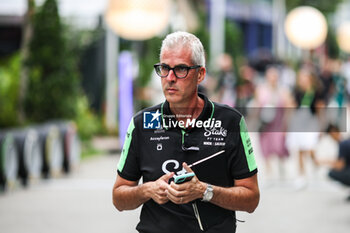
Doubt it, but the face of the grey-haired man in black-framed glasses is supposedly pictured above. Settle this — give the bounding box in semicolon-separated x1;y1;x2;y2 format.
160;47;205;105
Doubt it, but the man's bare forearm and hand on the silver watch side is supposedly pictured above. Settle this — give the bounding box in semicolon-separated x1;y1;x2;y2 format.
167;164;260;213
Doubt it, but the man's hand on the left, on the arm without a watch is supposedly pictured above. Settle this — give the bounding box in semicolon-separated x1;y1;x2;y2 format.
148;172;174;205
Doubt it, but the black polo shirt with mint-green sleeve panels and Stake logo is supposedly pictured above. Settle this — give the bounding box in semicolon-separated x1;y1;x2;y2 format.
118;94;257;233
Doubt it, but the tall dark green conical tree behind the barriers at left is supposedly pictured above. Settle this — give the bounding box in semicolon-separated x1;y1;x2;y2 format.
26;0;79;122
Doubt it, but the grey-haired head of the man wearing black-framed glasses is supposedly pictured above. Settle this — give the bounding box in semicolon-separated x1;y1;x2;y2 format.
156;32;206;106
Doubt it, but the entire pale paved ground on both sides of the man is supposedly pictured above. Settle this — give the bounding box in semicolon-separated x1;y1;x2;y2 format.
0;147;350;233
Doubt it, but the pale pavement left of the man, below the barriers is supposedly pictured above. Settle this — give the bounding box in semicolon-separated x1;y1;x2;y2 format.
0;155;138;233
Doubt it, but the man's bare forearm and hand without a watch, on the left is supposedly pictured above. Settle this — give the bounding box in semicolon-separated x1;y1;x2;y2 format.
113;173;174;211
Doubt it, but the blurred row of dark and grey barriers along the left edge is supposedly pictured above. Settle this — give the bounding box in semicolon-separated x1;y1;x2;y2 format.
0;121;81;190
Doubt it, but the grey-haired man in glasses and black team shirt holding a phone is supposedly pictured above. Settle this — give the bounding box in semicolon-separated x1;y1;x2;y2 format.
113;32;259;233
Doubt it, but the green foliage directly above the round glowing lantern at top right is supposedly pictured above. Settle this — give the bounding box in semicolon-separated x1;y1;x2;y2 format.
286;0;343;14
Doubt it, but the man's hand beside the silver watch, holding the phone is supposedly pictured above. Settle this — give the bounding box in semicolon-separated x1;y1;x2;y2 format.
166;163;206;204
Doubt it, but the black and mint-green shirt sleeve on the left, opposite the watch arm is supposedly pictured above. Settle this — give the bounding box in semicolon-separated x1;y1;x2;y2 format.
118;118;141;181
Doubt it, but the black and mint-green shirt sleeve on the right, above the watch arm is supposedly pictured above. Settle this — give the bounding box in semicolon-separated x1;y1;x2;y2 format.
230;117;257;179
